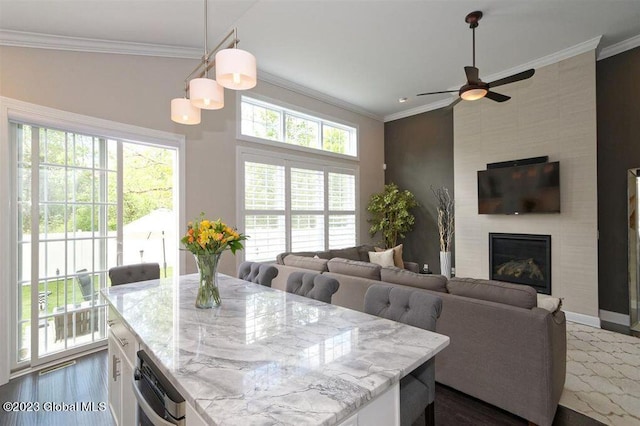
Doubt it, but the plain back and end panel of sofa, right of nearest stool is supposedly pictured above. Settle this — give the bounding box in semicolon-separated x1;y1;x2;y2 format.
436;293;566;426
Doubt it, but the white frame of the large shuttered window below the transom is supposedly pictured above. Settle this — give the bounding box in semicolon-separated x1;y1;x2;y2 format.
236;146;360;261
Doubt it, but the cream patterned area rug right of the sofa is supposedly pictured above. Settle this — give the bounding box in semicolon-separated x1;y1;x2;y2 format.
560;321;640;426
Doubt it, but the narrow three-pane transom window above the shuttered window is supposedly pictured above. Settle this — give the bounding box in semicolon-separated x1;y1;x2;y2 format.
239;96;358;157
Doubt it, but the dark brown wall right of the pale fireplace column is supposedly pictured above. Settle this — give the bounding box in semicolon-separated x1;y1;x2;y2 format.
596;48;640;314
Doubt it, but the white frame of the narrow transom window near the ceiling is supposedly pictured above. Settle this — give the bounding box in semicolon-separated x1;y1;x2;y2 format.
236;92;360;161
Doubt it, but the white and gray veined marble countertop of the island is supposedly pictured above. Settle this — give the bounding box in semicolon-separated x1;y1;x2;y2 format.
104;274;449;425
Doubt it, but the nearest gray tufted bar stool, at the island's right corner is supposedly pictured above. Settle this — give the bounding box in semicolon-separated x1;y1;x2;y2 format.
364;284;442;426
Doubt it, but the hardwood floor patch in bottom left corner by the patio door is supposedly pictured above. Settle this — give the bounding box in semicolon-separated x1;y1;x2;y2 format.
0;349;115;426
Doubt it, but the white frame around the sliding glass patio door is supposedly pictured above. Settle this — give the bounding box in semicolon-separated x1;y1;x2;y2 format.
0;96;186;385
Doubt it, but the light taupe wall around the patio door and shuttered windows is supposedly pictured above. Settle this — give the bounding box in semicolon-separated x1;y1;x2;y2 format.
0;47;384;273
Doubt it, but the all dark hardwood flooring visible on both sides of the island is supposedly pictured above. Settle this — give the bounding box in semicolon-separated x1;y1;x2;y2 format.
0;350;602;426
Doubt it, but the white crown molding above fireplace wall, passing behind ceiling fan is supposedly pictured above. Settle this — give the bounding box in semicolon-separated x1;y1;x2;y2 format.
384;35;604;122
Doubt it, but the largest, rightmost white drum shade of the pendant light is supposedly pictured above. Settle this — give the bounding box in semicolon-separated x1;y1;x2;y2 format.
216;48;258;90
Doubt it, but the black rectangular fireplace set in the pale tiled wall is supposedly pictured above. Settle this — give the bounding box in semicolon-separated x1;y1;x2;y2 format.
489;232;551;294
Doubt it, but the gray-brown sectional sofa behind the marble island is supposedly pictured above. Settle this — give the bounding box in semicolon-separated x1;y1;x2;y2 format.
272;253;566;425
